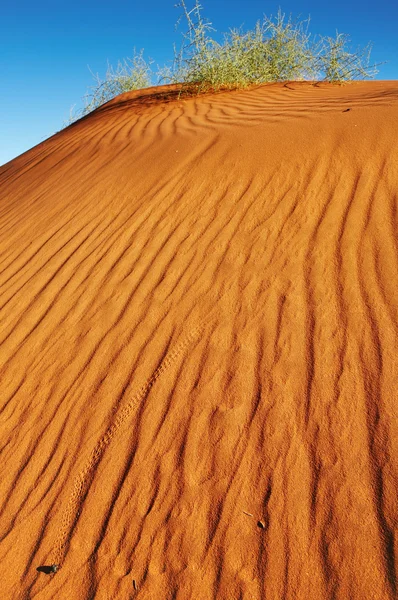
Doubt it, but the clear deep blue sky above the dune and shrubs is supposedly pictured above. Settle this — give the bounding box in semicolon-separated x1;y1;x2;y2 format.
0;0;398;165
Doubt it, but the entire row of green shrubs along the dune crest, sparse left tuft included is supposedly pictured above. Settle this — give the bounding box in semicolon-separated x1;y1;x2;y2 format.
69;0;378;123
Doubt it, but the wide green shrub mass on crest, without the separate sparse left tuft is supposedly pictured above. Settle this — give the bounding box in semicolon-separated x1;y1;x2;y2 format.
164;0;377;92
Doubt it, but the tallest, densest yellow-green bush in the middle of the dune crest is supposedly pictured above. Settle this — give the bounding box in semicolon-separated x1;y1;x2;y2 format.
164;0;312;92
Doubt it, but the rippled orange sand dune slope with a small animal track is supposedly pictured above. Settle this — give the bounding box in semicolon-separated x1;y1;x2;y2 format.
0;82;398;600
